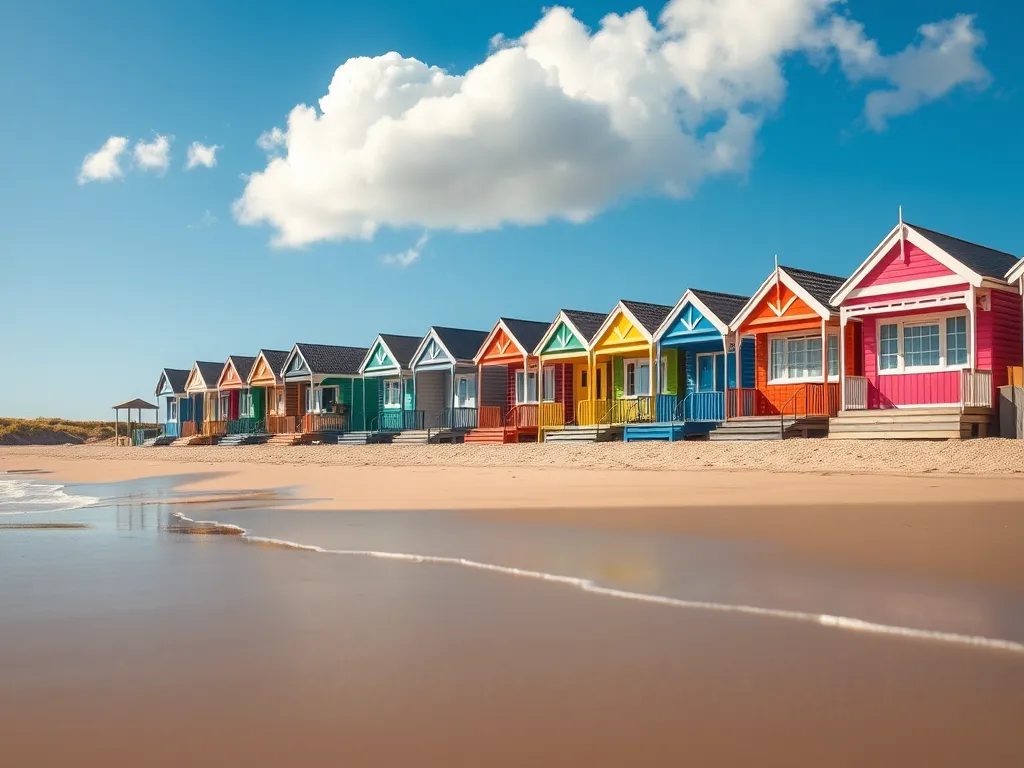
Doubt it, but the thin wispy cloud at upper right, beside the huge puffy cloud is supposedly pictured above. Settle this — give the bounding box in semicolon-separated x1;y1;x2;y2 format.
833;14;991;130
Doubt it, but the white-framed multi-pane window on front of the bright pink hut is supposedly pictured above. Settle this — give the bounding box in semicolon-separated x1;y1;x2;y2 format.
878;314;970;374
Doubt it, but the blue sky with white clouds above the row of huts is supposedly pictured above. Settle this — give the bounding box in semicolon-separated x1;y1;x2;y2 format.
0;0;1024;419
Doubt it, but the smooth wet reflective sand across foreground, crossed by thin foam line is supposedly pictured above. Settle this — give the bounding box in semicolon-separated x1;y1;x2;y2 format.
0;477;1024;766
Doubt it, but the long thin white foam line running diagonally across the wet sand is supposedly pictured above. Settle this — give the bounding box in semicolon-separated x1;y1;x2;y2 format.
172;512;1024;654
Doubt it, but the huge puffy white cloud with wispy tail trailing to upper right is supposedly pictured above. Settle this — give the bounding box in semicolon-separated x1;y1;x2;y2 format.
234;0;983;247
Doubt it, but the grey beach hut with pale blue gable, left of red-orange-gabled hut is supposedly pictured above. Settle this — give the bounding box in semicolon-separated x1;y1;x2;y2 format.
401;326;487;442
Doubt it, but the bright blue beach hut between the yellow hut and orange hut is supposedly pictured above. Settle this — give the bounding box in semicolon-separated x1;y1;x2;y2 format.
623;289;754;441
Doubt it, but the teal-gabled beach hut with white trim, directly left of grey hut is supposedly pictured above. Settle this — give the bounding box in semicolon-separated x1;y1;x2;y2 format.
359;334;426;441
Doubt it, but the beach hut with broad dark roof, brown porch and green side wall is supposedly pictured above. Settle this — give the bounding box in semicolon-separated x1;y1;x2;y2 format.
271;343;377;444
